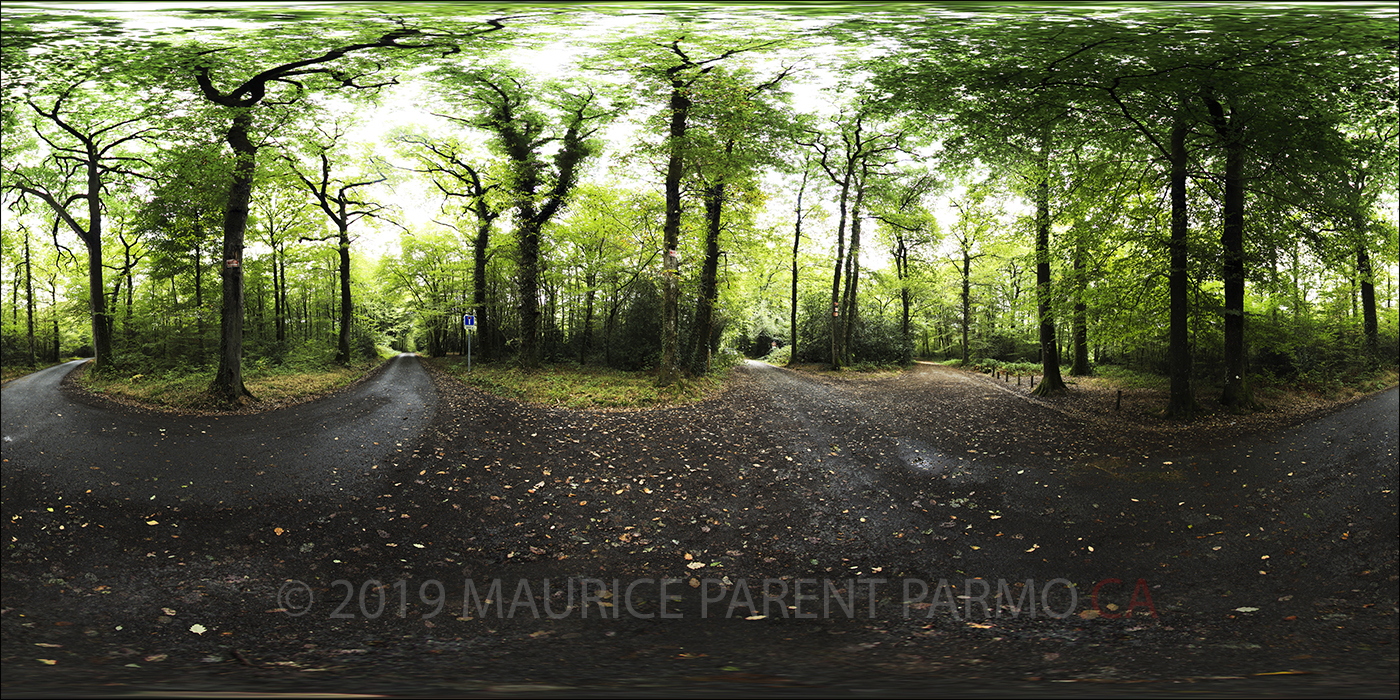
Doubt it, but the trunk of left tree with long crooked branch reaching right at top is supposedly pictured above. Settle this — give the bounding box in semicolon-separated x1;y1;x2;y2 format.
209;111;258;405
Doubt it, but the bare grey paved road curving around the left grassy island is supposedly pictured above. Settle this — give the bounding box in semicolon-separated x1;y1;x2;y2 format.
0;354;437;505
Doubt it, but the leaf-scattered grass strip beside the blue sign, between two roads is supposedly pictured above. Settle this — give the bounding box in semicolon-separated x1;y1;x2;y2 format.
428;357;724;410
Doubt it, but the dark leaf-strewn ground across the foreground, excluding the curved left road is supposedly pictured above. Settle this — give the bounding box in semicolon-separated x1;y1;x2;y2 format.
0;363;1400;697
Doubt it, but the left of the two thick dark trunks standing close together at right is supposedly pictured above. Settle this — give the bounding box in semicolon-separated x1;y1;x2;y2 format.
1166;106;1197;419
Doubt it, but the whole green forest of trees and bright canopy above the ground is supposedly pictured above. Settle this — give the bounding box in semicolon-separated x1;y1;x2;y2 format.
0;3;1400;416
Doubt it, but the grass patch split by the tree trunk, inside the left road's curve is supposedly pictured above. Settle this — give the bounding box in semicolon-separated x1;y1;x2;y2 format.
77;360;382;412
